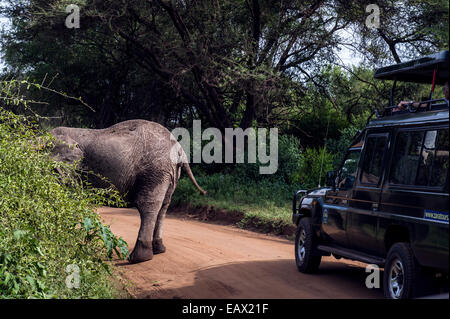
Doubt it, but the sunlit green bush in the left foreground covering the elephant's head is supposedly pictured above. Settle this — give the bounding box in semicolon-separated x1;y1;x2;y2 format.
0;106;128;298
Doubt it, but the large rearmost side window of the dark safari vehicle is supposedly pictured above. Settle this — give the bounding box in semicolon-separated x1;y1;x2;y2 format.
390;129;449;187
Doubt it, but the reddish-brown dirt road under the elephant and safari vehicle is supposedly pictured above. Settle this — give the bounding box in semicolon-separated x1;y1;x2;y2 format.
99;208;383;299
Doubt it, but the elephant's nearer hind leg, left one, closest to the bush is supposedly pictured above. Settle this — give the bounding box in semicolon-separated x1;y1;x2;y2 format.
129;185;167;263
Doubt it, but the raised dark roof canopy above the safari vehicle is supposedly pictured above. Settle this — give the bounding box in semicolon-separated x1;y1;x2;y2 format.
374;50;449;85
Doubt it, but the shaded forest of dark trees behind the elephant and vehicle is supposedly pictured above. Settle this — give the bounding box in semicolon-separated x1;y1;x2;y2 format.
1;0;448;187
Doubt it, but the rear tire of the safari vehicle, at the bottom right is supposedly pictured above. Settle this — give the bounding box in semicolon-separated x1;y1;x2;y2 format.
383;243;420;299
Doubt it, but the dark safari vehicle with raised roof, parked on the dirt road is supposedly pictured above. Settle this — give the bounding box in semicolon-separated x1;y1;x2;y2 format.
293;51;449;299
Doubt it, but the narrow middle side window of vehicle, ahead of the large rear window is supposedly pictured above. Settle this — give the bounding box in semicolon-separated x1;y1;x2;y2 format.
361;135;387;185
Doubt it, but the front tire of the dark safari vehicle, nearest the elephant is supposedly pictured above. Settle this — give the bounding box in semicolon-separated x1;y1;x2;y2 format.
295;217;322;273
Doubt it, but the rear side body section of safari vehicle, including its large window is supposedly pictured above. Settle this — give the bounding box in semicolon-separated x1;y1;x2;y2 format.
378;123;449;268
